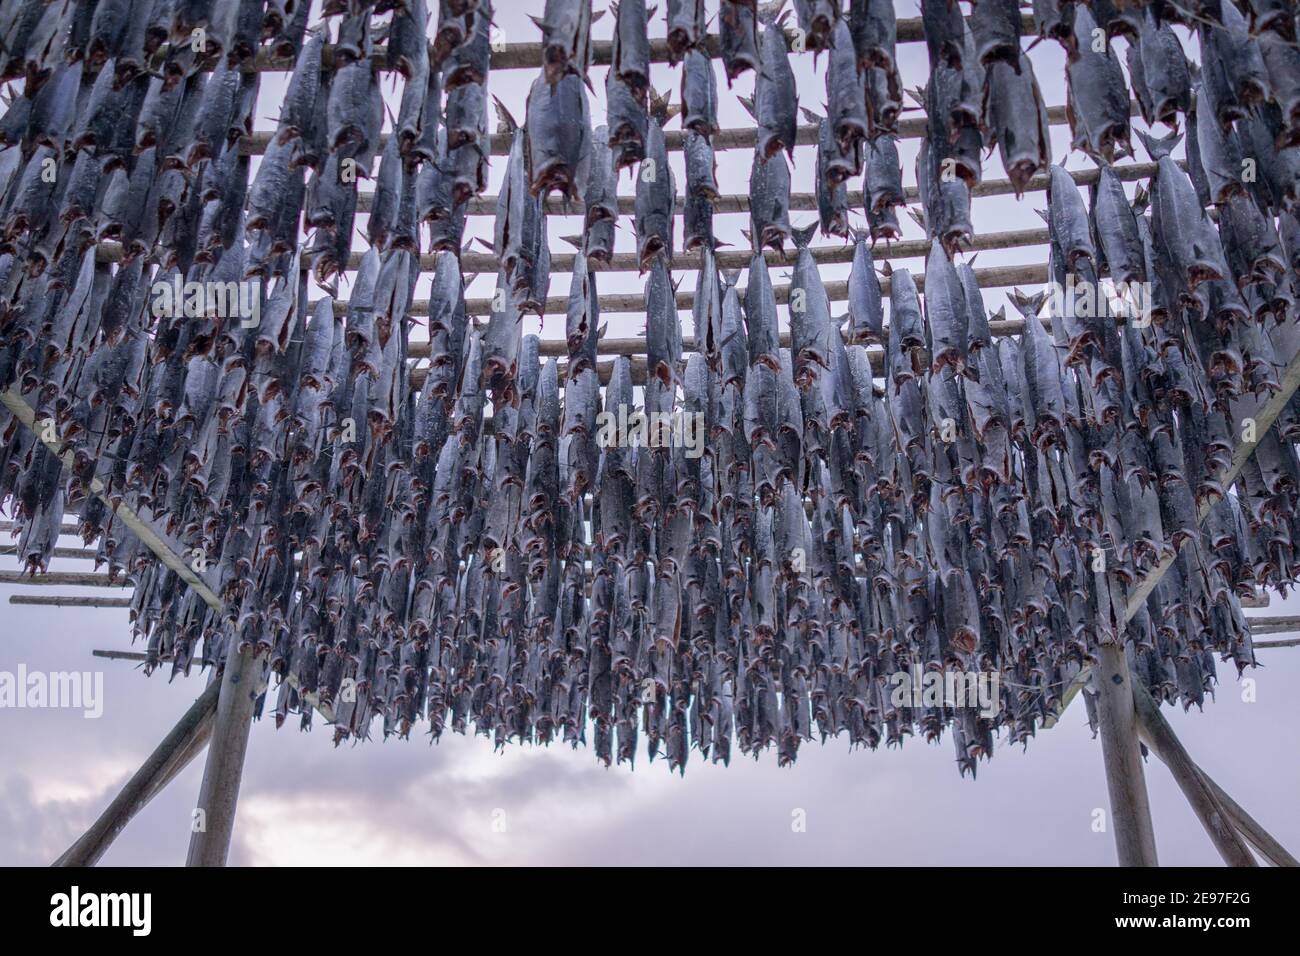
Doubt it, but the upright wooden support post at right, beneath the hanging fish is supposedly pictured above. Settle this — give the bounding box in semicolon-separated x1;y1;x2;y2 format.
1093;644;1158;866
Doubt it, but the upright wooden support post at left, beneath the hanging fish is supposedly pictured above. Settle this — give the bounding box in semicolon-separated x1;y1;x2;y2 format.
185;648;263;866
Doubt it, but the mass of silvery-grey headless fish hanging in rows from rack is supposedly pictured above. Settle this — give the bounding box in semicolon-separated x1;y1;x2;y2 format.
0;0;1300;771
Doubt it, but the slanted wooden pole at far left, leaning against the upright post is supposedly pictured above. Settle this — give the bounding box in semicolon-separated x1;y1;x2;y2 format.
53;680;221;866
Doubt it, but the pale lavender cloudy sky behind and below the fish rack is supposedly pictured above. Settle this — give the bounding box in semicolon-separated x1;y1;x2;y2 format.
0;0;1300;866
